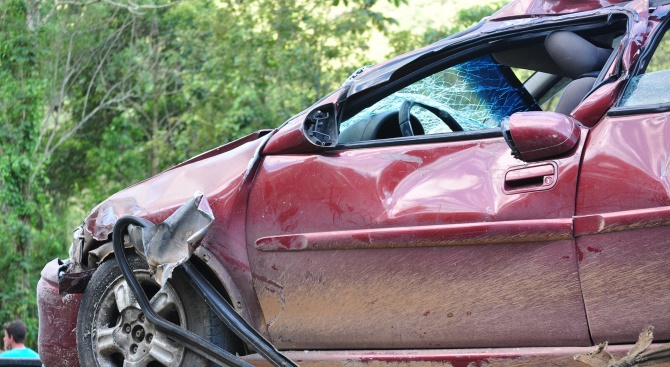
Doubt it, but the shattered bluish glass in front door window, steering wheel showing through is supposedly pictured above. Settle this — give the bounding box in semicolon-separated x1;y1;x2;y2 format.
339;55;538;143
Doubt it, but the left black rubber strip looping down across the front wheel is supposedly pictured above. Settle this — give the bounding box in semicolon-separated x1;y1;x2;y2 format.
112;216;253;367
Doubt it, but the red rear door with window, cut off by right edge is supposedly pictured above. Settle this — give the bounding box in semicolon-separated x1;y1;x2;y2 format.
575;5;670;343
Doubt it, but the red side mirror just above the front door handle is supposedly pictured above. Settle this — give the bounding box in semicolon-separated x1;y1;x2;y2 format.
501;111;581;162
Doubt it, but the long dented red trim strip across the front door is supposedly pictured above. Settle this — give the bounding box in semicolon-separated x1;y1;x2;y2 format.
256;218;572;251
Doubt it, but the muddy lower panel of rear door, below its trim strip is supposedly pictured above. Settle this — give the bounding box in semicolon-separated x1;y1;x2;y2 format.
577;227;670;343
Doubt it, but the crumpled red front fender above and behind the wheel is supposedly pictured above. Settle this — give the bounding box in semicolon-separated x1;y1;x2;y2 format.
85;135;269;332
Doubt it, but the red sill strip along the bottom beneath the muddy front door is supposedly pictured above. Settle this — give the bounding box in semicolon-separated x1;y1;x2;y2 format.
242;344;661;367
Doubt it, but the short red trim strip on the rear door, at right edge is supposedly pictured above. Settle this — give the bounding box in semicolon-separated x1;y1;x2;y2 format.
574;206;670;236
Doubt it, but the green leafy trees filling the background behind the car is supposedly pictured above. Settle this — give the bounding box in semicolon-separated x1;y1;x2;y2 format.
0;0;506;347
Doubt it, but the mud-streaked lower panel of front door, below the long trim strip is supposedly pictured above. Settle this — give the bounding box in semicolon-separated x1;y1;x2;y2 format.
249;241;589;349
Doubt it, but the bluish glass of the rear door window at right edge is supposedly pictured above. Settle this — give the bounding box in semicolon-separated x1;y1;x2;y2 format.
619;27;670;107
